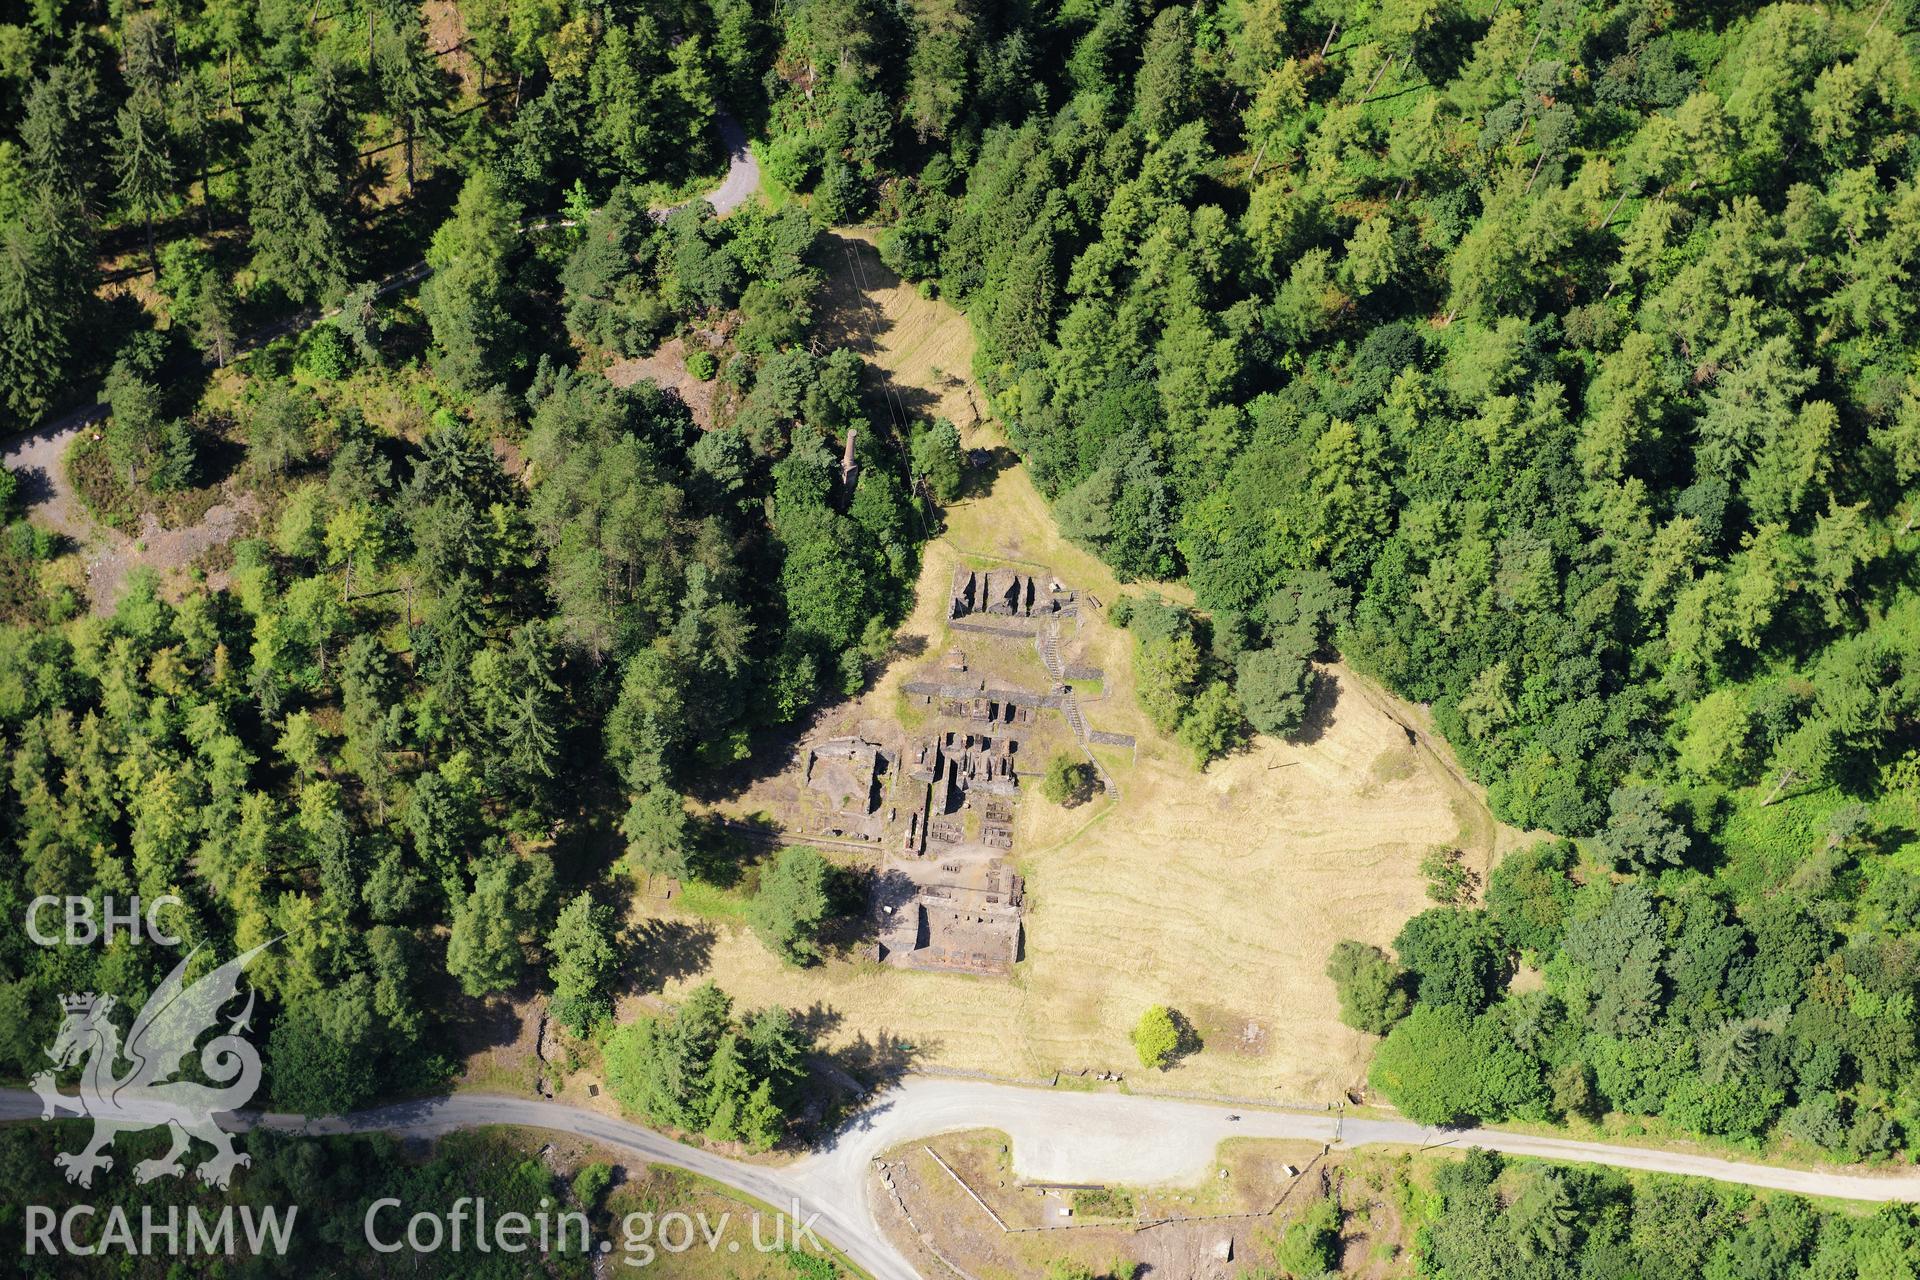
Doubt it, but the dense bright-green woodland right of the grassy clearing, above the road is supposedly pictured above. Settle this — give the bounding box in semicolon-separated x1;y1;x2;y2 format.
741;0;1920;1159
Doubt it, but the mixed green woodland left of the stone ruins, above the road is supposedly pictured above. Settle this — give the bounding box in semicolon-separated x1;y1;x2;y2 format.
0;2;924;1146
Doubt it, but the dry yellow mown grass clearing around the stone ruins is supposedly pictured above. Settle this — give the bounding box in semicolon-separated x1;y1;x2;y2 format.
629;227;1517;1102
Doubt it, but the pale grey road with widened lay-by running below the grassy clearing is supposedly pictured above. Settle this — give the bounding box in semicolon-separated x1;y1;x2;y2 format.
0;1077;1920;1280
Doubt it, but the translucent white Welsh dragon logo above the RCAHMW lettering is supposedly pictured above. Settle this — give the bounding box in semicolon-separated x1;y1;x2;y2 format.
33;942;271;1190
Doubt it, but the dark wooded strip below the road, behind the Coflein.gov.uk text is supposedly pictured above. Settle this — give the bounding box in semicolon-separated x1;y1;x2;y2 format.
0;1125;852;1280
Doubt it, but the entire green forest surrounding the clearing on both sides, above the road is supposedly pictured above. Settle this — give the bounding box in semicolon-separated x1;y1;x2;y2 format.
0;0;1920;1220
